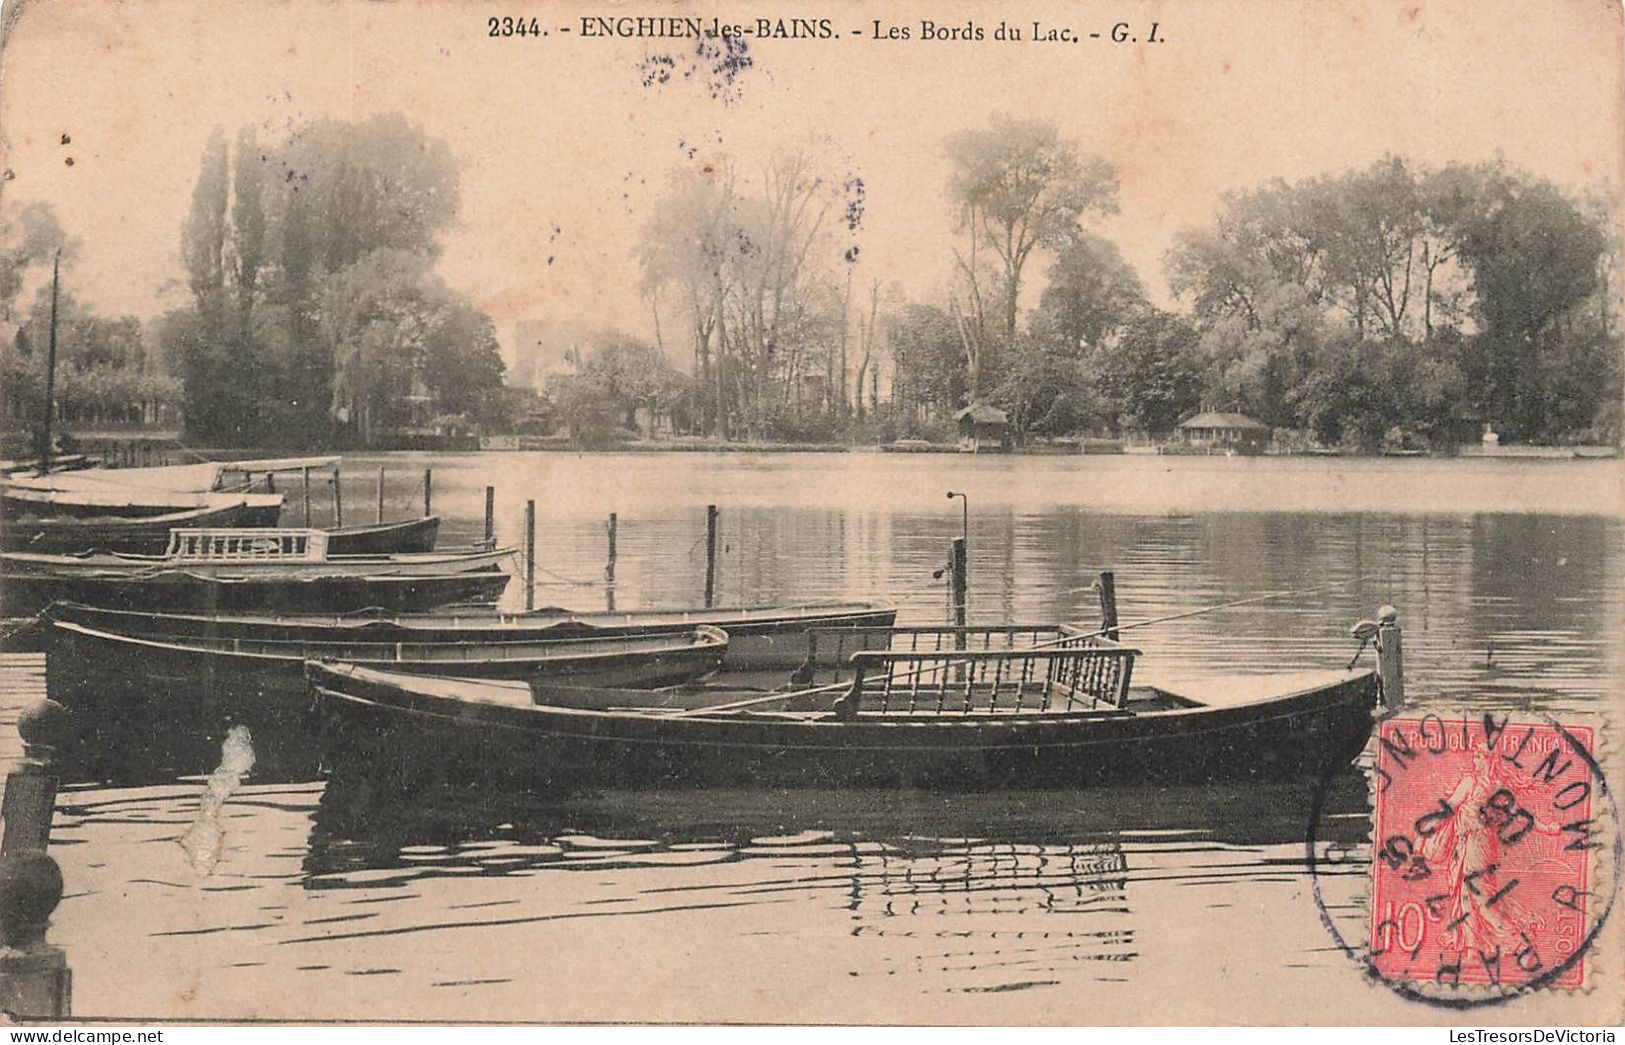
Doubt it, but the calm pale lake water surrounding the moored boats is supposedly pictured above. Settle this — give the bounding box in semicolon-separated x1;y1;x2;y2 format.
15;453;1625;1022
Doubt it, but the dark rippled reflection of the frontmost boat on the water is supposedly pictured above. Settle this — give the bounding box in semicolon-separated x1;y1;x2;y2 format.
289;772;1368;993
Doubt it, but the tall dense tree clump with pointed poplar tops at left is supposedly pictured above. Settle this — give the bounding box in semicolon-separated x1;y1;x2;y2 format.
166;115;501;444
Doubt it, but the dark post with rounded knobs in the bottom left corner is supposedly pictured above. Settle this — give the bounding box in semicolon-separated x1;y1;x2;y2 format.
0;653;73;1019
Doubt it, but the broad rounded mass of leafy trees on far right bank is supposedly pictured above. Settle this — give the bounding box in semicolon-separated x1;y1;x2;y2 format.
1168;158;1620;445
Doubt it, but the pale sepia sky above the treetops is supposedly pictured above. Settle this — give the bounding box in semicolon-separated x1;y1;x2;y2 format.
0;0;1625;367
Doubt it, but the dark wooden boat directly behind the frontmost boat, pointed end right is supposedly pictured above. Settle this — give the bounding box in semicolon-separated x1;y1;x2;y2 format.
47;611;728;704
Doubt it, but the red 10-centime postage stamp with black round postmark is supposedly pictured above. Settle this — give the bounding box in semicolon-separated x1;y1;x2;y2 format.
1370;713;1599;988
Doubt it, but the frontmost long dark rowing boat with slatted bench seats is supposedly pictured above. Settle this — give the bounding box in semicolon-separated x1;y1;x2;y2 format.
306;635;1378;791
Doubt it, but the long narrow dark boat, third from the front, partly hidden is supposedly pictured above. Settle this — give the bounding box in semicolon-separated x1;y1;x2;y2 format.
38;600;897;669
